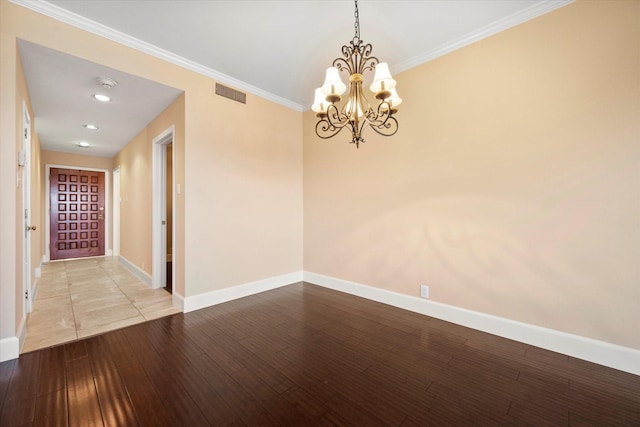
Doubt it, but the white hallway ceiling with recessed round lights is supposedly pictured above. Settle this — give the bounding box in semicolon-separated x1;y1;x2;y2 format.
18;40;181;157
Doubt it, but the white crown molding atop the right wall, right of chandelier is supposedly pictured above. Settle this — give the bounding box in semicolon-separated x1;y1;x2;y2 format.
391;0;575;74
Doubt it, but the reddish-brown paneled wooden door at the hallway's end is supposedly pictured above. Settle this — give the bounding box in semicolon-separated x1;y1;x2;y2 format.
50;168;105;260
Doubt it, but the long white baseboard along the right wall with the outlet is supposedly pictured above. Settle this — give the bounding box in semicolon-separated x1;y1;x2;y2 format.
303;271;640;375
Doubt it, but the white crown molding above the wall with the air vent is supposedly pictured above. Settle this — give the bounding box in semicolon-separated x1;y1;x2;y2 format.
9;0;304;112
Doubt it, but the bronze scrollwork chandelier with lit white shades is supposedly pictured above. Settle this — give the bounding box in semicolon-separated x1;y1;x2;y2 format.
311;0;402;148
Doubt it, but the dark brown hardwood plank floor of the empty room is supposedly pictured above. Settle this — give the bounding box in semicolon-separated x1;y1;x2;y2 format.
0;283;640;427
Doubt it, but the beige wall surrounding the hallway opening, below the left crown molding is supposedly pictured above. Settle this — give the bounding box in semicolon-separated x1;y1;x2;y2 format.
0;0;302;350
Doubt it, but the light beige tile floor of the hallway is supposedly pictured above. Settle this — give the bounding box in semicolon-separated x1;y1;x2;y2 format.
22;257;180;353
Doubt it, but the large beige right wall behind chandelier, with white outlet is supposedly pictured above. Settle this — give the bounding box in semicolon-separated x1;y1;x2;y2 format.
304;1;640;349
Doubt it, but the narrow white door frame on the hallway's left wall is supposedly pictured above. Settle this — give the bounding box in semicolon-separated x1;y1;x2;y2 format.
19;101;33;316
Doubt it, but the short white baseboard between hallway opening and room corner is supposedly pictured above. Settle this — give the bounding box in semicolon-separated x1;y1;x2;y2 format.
183;271;302;313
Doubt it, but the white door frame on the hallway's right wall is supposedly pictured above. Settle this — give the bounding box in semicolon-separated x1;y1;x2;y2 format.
151;125;176;289
